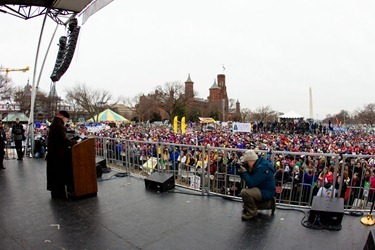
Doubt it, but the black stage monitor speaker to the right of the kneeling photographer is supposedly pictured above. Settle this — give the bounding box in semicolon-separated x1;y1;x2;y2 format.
308;196;344;227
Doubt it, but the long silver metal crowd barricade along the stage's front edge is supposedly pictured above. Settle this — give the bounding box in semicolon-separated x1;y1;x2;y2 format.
92;137;375;212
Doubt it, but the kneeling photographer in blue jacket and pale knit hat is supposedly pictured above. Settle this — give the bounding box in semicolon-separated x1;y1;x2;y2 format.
237;150;276;220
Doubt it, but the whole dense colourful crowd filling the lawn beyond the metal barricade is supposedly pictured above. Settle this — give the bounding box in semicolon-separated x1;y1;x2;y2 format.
30;119;375;204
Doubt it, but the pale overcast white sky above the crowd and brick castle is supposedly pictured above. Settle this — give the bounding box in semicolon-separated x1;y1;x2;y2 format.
0;0;375;119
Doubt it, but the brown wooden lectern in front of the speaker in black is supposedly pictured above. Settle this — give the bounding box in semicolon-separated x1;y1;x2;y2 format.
72;138;98;197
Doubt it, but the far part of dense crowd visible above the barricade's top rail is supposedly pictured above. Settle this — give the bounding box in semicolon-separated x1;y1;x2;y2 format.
66;119;375;155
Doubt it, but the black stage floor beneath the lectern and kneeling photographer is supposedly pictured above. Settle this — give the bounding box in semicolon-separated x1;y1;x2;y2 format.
0;158;372;250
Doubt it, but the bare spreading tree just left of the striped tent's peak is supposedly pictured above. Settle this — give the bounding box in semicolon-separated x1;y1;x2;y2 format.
66;84;117;122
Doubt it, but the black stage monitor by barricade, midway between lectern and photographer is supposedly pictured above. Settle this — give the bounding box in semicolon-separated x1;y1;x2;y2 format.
145;172;175;192
